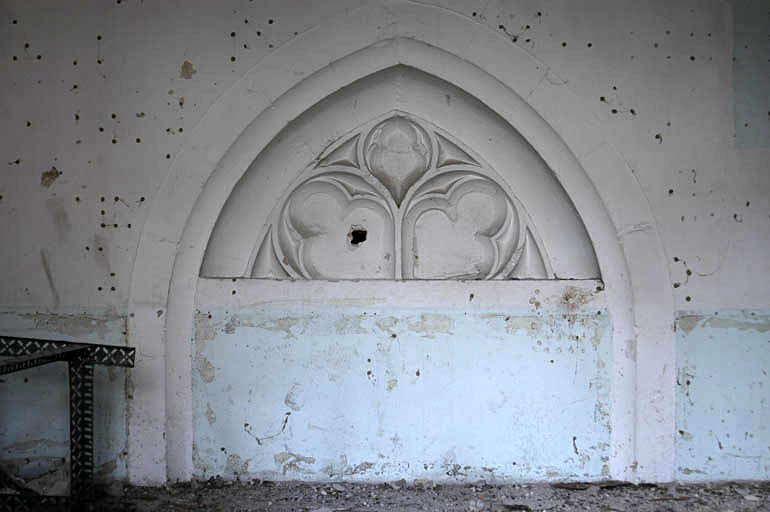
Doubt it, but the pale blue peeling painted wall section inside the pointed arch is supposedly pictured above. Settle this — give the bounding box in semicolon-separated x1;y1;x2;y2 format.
193;308;611;480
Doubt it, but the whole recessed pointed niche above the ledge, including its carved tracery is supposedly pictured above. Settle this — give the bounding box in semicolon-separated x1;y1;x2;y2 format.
200;65;600;280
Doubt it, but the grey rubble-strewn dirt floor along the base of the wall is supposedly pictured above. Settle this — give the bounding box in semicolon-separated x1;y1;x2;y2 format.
91;478;770;512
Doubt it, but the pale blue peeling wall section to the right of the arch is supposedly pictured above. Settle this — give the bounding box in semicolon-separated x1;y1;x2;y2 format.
676;311;770;480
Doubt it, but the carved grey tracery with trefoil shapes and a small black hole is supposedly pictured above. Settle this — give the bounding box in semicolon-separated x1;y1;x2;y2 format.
249;112;554;280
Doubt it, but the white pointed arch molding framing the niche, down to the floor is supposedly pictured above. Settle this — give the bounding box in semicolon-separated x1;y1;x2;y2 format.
128;2;674;484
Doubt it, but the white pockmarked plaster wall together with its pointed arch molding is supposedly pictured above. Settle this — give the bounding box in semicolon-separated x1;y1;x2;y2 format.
7;0;770;483
